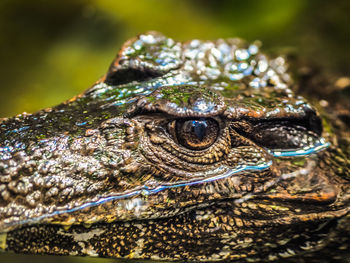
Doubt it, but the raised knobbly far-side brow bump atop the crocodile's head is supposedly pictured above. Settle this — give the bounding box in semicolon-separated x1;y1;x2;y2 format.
104;32;181;86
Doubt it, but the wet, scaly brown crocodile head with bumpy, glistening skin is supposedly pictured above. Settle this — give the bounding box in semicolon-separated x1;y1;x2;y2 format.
0;32;350;262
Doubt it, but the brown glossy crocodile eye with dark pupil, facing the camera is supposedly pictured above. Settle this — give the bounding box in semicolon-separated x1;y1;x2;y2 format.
173;118;219;150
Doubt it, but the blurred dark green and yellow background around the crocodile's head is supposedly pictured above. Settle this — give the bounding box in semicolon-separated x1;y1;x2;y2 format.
0;0;350;263
